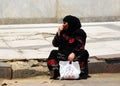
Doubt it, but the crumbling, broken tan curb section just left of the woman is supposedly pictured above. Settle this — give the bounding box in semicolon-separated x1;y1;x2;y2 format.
8;60;48;78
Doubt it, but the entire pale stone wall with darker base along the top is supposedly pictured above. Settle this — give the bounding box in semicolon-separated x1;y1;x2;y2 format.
0;0;120;24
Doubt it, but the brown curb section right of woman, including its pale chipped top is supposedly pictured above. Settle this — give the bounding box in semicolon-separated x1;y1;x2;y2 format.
88;57;120;74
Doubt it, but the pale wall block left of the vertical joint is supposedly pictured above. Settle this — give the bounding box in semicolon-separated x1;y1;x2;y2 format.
0;0;56;18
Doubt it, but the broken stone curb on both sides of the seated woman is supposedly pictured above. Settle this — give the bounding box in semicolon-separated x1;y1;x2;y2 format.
0;55;120;79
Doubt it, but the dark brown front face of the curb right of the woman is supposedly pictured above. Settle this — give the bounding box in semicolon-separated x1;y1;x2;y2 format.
89;62;120;74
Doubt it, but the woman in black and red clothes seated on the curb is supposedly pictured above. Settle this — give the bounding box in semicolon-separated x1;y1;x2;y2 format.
47;15;89;79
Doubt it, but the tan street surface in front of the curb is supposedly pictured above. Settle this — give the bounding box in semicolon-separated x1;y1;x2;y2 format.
0;73;120;86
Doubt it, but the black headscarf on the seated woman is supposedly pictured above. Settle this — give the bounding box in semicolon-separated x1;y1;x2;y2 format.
63;15;81;34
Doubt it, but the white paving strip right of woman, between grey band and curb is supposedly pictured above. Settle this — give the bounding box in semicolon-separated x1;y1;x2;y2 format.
86;40;120;56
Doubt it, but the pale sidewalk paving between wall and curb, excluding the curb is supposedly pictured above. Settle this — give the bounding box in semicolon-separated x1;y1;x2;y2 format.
0;22;120;60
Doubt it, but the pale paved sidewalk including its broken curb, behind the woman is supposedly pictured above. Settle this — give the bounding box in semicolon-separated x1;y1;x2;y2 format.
0;22;120;78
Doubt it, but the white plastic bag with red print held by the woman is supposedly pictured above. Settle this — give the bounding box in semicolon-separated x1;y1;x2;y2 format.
59;61;81;79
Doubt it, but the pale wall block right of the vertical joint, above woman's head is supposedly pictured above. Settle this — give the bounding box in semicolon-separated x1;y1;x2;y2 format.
58;0;120;17
